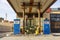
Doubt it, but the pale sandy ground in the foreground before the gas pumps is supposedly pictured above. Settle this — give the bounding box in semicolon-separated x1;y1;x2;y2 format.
0;35;60;40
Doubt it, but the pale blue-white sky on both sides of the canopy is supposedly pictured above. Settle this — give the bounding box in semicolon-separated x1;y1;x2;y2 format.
0;0;60;21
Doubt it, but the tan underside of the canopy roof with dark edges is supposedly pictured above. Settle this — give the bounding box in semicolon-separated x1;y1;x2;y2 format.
7;0;56;13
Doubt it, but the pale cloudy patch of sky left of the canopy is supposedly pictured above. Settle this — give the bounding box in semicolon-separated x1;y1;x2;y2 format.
0;0;16;20
